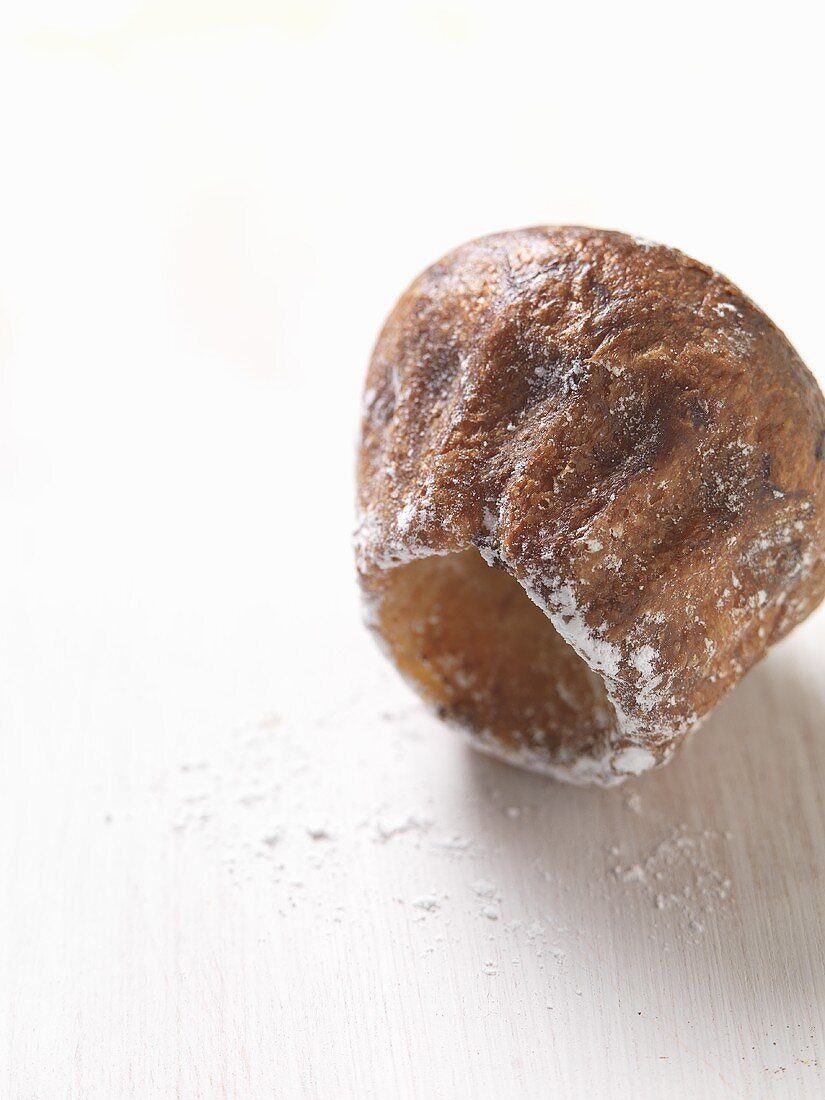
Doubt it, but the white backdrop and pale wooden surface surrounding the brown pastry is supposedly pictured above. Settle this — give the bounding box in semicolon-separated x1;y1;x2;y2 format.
0;0;825;1100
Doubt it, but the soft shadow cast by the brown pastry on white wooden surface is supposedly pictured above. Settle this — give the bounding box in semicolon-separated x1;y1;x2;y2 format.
459;644;825;1048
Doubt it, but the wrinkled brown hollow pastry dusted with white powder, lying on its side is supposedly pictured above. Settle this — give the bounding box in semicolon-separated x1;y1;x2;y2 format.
356;228;825;783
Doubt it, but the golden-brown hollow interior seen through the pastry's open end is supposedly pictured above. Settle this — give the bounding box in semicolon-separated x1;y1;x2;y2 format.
380;549;615;756
